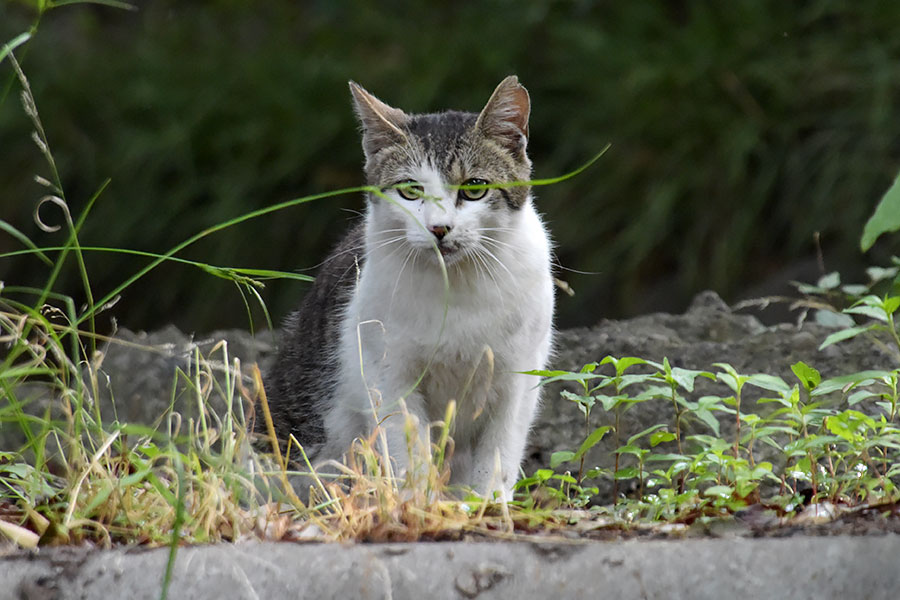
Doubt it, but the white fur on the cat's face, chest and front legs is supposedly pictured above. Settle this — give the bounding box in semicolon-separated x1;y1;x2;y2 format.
317;167;554;499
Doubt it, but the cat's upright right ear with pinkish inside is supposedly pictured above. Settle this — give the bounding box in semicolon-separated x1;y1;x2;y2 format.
475;75;531;155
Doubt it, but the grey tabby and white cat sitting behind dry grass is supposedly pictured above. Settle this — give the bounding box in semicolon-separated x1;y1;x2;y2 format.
257;76;554;500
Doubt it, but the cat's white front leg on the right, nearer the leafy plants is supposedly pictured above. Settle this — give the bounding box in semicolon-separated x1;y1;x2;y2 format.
470;373;540;501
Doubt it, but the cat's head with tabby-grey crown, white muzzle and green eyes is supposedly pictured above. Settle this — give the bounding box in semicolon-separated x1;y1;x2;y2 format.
350;76;531;264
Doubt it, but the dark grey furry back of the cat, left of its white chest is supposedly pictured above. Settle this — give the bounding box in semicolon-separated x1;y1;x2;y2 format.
256;222;364;445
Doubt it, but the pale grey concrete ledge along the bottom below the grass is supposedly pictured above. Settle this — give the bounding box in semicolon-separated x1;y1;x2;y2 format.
0;534;900;600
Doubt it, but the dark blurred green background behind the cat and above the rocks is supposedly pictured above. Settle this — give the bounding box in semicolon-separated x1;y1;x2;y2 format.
0;0;900;332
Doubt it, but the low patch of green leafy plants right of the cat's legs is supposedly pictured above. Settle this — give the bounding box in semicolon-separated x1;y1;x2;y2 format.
527;357;900;520
